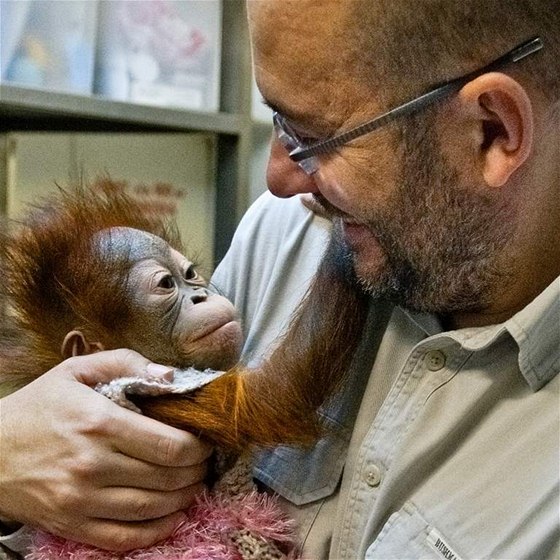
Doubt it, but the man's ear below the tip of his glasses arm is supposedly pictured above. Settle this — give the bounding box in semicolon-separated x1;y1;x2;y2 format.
459;72;534;187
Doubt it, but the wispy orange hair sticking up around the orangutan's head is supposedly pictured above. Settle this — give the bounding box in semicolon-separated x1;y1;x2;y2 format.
0;179;181;384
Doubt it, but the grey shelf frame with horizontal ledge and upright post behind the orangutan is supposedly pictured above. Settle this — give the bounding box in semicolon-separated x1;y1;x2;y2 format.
0;0;263;261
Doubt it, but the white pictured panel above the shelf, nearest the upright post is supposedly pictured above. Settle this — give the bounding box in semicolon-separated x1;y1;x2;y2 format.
94;0;222;111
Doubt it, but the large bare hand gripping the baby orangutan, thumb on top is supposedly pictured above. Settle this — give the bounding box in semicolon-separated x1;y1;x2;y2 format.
0;350;212;551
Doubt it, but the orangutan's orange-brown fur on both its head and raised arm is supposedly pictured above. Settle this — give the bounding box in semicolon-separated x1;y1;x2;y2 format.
0;180;367;451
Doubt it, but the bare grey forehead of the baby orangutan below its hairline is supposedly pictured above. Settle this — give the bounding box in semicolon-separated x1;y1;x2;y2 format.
94;227;169;262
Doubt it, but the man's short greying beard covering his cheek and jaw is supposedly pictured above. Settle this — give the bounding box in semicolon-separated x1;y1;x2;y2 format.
335;126;514;314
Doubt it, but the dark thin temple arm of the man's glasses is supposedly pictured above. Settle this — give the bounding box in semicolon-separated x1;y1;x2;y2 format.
290;37;543;162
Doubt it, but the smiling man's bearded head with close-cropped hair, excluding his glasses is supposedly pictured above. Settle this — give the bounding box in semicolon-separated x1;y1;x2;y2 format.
249;0;560;321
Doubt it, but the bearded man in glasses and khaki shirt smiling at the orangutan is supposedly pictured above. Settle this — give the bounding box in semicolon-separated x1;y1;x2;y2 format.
214;0;560;560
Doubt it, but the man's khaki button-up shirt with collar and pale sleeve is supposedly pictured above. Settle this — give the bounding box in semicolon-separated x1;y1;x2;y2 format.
214;194;560;560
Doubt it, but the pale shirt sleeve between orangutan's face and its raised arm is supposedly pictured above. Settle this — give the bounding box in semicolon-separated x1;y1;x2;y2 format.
211;192;330;363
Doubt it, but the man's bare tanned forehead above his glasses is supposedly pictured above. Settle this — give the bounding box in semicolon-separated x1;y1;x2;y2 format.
249;0;371;128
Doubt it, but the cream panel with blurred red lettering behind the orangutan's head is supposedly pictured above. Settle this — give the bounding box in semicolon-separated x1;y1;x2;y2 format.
6;133;216;275
